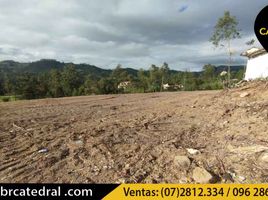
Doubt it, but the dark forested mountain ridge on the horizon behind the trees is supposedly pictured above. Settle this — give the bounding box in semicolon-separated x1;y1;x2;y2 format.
0;59;244;77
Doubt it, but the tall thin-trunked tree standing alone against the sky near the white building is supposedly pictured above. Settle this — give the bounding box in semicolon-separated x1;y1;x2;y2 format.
210;11;240;86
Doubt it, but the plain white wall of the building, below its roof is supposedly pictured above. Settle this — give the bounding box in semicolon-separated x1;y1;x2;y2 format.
245;54;268;80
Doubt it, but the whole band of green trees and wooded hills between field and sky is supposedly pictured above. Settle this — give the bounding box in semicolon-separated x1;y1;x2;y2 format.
0;60;244;101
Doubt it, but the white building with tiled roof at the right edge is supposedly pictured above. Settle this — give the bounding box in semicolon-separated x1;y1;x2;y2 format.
241;47;268;81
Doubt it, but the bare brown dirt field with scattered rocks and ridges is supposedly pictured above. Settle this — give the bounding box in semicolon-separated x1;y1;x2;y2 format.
0;82;268;183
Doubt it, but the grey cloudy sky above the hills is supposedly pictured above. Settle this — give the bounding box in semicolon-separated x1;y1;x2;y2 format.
0;0;268;71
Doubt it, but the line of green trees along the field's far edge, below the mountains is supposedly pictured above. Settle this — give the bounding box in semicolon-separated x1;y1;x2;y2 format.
0;63;244;99
